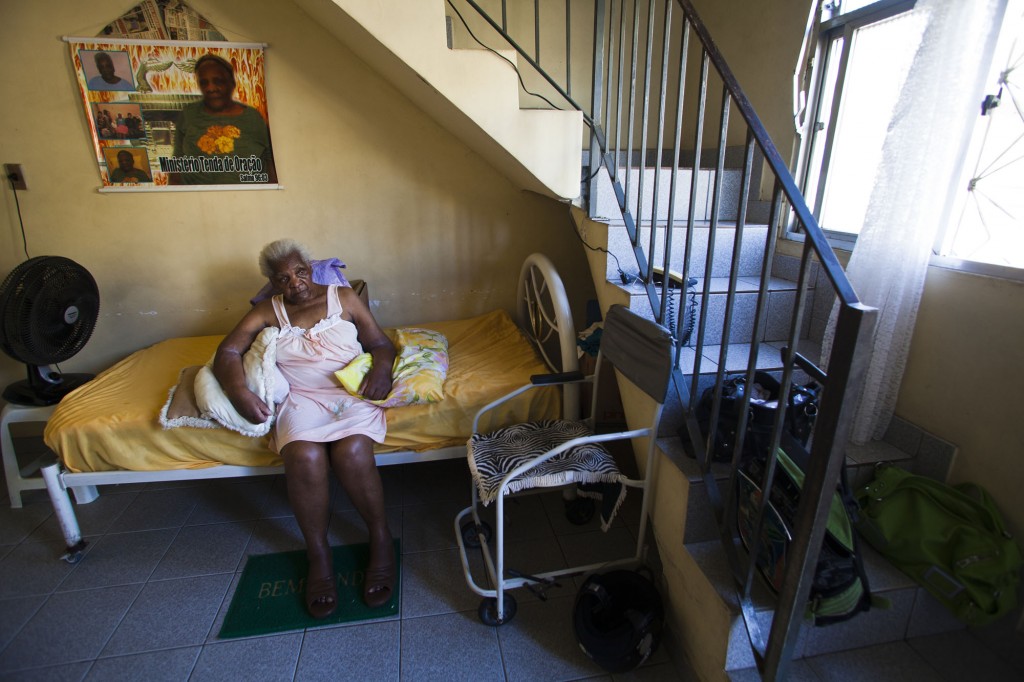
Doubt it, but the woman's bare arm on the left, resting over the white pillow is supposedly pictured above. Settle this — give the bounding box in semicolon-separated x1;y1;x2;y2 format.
213;299;275;424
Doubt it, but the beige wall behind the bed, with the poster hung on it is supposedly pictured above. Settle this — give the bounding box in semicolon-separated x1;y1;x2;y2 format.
0;0;593;385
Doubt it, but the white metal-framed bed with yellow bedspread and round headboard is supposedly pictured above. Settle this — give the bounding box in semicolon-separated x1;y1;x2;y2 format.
41;254;579;563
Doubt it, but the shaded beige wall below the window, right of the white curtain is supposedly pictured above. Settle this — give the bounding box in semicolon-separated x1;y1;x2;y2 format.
896;267;1024;539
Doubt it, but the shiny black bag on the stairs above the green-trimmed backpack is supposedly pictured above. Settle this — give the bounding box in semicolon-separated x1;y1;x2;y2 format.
695;372;821;462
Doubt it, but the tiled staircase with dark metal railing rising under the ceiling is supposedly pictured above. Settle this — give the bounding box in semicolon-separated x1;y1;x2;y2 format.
296;0;974;680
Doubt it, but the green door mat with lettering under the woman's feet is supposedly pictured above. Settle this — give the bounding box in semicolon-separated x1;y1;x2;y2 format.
219;540;401;638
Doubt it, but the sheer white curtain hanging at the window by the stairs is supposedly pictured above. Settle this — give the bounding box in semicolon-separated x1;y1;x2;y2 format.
824;0;1005;443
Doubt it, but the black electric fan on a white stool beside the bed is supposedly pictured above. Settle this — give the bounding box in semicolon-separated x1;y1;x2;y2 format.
0;256;99;406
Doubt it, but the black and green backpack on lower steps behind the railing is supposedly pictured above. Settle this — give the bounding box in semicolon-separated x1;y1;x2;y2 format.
736;433;873;626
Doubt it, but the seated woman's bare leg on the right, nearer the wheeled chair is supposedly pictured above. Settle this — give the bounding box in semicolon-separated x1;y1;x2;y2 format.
331;435;394;606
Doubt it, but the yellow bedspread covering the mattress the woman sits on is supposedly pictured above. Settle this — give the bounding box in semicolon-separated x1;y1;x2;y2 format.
43;310;560;472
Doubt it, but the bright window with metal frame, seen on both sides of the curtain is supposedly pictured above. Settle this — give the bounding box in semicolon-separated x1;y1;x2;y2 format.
796;0;1024;276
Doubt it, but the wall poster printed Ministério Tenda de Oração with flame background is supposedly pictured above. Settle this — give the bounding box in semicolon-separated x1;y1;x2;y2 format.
67;37;278;191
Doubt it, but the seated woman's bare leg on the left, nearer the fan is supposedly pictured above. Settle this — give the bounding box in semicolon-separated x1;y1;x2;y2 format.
281;440;338;617
